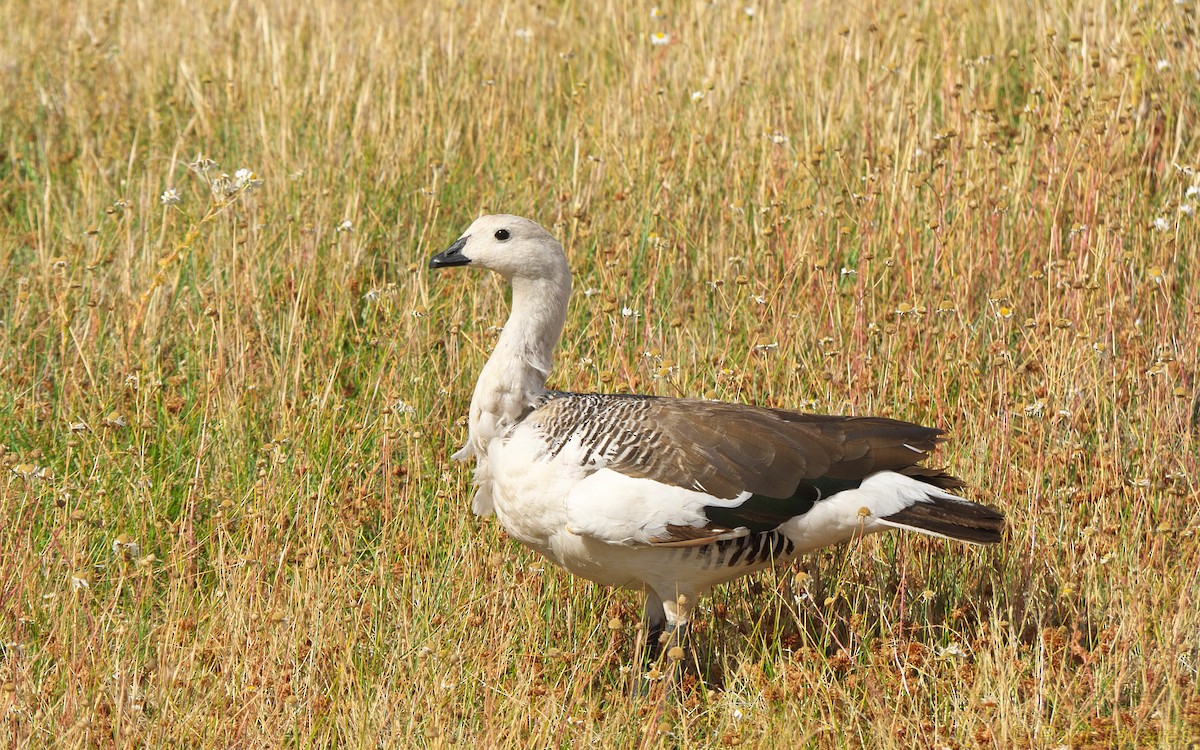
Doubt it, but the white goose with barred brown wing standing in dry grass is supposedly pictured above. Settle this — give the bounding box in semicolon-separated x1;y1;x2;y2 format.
430;215;1004;658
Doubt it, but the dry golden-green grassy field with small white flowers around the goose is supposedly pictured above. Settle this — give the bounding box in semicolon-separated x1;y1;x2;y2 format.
0;0;1200;748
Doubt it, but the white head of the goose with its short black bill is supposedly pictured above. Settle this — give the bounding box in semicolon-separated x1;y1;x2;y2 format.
430;214;570;281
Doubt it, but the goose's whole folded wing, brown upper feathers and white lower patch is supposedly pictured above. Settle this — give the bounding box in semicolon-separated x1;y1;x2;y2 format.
527;394;961;546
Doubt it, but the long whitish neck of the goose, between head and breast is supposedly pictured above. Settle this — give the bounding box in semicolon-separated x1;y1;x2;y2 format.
470;266;571;452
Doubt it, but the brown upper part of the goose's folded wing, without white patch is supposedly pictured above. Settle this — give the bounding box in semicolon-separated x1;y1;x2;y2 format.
529;394;958;499
